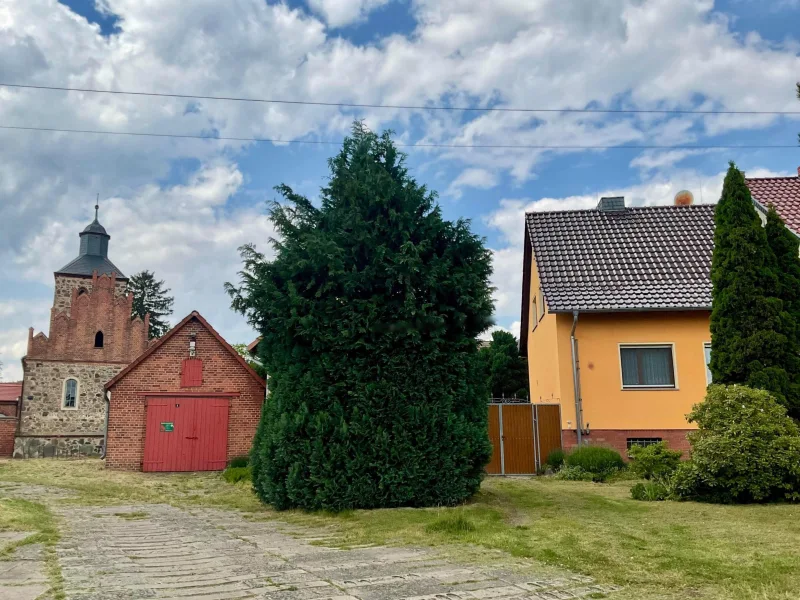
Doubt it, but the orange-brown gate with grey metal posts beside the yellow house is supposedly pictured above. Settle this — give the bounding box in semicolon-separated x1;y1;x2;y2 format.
486;402;561;475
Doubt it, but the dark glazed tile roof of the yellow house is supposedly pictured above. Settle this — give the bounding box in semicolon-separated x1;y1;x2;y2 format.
526;205;714;312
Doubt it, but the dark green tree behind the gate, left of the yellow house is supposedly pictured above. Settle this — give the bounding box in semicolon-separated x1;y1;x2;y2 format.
480;331;529;398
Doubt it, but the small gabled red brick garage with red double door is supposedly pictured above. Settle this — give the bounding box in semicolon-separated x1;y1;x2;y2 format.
101;311;266;471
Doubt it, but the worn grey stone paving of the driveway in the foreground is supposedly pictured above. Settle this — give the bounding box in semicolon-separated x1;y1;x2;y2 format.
0;485;619;600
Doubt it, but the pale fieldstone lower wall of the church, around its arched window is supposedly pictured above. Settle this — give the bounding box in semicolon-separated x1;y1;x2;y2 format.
20;359;125;437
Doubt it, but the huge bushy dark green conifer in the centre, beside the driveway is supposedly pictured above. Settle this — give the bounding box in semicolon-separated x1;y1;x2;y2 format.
226;123;492;511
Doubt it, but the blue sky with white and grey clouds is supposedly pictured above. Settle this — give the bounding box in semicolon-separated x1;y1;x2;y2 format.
0;0;800;379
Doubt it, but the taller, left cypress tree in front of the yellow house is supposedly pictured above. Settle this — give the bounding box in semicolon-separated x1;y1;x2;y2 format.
710;163;791;402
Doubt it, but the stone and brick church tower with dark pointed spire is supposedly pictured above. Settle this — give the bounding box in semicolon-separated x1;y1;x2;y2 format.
14;207;149;457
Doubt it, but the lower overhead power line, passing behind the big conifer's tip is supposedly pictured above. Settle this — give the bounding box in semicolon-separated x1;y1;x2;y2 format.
0;125;798;150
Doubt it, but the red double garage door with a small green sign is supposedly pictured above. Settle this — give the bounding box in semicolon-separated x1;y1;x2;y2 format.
142;397;228;471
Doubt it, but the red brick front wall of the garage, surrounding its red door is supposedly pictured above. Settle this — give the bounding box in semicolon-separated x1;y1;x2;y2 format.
106;318;265;470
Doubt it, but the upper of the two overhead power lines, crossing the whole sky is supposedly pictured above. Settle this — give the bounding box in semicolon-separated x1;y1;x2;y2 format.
0;82;800;116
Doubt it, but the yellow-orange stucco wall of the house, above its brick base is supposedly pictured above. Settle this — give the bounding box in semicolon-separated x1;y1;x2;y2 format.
528;254;711;430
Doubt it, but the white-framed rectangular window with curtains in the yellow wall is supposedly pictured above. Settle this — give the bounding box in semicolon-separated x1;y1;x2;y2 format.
619;344;677;390
